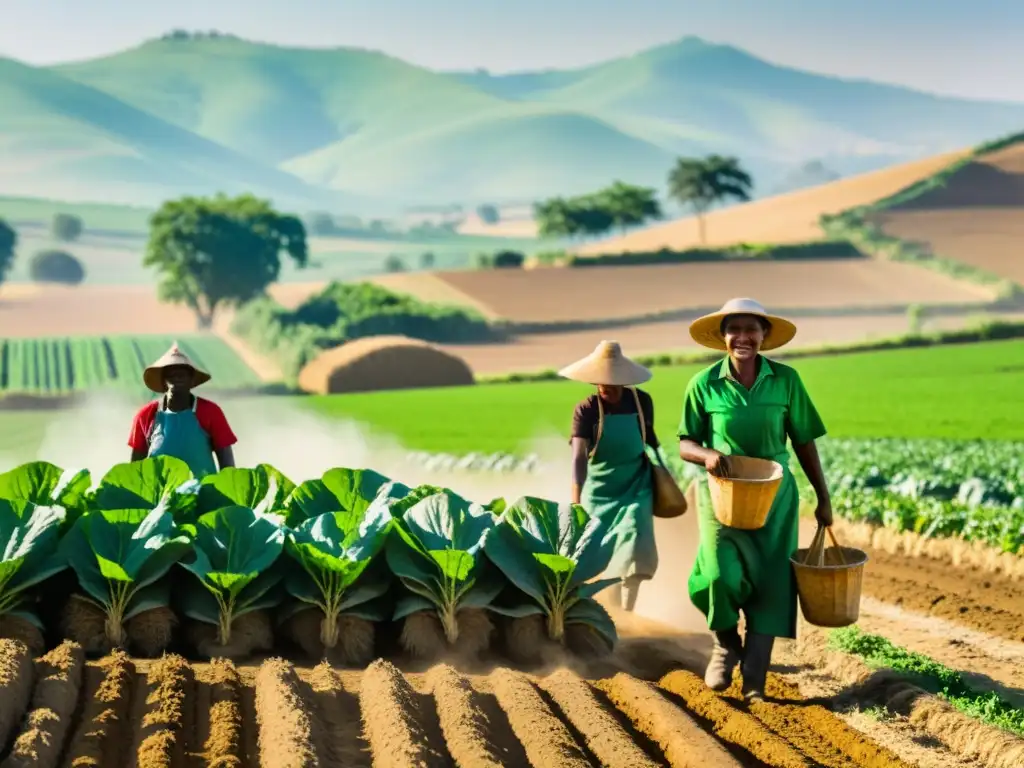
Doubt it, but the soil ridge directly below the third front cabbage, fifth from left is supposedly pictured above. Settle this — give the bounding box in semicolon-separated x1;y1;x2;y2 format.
197;658;243;768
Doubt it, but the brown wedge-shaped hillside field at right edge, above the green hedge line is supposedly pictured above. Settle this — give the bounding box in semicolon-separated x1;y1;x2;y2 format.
877;144;1024;284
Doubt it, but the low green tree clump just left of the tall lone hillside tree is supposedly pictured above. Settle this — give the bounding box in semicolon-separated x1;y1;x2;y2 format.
534;181;662;238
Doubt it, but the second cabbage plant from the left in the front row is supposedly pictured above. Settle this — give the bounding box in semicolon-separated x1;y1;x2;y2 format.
60;508;191;646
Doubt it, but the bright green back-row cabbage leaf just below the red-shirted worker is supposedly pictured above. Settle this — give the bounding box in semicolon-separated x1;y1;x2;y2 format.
89;456;200;522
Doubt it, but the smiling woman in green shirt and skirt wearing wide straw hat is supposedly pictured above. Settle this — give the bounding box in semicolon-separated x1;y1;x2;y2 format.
679;299;833;698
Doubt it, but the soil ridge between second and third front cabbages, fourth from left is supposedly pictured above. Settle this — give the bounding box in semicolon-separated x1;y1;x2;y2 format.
135;654;194;768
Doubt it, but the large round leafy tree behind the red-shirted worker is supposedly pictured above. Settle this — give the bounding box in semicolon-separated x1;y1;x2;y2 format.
142;195;308;328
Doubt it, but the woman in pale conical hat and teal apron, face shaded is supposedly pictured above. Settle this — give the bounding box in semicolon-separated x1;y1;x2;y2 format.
559;341;660;610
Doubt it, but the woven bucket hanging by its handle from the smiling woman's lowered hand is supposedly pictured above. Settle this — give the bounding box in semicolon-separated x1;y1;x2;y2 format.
790;526;867;628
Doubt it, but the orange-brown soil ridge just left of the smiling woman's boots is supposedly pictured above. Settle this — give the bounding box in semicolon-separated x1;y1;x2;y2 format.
658;670;814;768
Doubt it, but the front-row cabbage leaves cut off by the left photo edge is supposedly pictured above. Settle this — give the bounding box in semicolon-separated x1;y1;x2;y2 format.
0;499;68;629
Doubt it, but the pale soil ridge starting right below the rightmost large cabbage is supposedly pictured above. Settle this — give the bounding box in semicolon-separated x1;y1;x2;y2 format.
540;670;667;768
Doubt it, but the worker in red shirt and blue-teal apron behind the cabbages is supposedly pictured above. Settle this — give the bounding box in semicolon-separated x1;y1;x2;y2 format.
128;342;238;477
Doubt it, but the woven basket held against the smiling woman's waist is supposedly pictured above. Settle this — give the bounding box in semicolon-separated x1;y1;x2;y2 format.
708;456;782;530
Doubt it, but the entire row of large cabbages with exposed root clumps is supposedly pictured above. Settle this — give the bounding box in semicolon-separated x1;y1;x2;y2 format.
0;458;618;664
